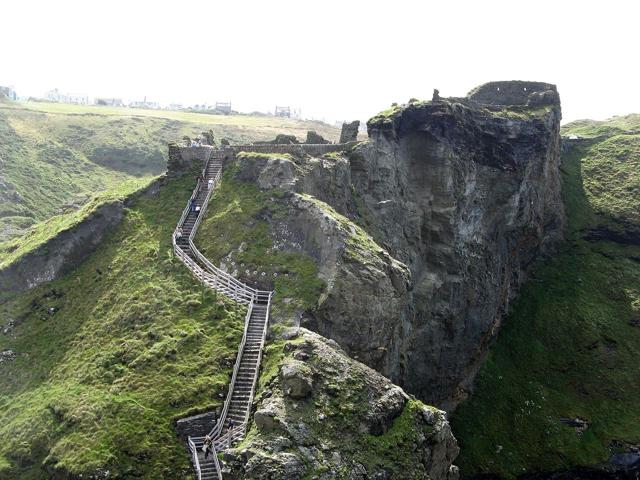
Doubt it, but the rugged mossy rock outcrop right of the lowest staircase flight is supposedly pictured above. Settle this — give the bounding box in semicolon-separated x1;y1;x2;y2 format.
223;329;458;480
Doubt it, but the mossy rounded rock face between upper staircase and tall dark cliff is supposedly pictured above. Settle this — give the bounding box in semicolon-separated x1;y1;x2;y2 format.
196;152;409;344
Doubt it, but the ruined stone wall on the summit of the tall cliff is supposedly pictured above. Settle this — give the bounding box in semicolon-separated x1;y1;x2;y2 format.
467;80;560;105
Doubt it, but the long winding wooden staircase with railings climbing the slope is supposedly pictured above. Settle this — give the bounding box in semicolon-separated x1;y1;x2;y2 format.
173;147;273;480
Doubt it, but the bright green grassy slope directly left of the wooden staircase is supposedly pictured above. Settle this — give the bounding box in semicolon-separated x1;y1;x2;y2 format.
0;166;244;479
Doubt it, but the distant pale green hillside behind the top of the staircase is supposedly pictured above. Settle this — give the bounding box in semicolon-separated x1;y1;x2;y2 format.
0;102;339;242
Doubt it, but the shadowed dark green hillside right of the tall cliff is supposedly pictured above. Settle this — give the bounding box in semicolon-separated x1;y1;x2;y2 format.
453;115;640;478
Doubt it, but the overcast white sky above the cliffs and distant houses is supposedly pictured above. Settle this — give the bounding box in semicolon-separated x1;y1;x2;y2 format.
0;0;640;121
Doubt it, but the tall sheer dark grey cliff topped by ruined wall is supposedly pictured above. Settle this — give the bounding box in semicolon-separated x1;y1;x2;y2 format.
336;82;565;407
